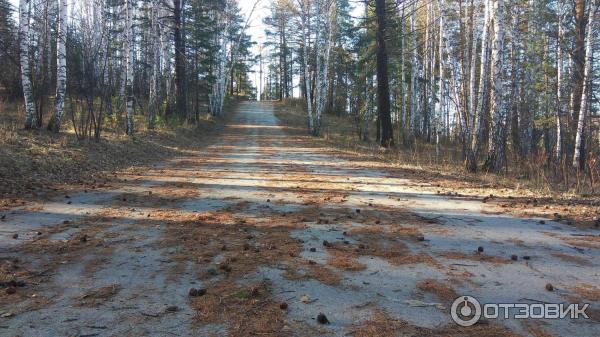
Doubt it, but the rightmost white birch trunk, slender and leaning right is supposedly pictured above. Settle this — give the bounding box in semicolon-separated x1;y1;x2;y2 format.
573;0;598;171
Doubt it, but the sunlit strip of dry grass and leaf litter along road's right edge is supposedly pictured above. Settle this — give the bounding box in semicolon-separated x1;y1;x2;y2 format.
275;101;600;229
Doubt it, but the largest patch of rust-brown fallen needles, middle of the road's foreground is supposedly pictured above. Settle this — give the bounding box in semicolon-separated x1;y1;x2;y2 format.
157;202;340;336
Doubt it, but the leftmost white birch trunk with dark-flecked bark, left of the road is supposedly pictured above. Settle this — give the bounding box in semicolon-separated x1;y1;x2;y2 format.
19;0;36;129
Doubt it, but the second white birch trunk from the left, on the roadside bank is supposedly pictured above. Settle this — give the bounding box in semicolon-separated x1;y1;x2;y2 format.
48;0;68;133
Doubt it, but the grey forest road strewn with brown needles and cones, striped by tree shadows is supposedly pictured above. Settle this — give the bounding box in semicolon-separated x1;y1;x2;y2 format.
0;102;600;336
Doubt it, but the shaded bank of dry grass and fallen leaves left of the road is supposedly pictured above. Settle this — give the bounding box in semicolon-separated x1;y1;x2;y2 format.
0;101;230;209
